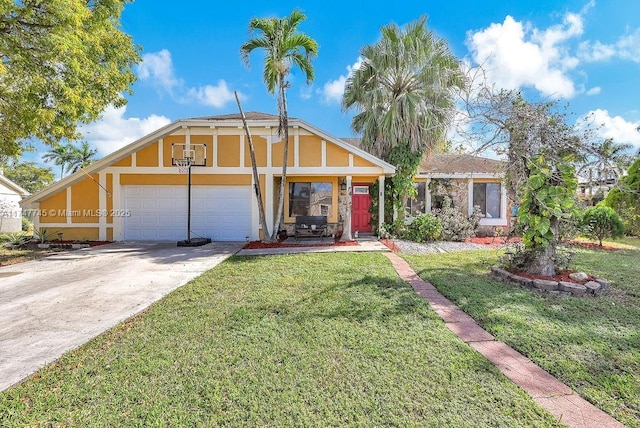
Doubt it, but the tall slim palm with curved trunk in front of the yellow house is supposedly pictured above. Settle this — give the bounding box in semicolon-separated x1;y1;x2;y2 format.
240;10;318;240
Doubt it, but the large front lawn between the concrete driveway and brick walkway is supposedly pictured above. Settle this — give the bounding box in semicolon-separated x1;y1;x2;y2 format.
0;253;556;427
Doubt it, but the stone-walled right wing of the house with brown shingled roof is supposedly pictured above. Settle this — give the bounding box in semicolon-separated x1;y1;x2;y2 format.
406;154;511;234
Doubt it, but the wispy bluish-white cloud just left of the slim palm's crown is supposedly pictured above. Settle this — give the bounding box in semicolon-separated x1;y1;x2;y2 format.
137;49;242;108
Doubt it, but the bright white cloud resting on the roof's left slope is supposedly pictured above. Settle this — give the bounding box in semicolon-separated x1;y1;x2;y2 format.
80;106;171;156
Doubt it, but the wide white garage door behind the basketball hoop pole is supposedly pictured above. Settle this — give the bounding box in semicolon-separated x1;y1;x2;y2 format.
123;186;252;241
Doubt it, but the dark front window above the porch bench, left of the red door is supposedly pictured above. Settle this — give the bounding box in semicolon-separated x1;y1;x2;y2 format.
289;182;333;217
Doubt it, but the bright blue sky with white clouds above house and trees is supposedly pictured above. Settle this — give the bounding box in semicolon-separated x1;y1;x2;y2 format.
29;0;640;165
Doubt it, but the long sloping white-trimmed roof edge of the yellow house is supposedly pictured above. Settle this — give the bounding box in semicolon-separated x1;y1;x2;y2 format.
22;112;396;206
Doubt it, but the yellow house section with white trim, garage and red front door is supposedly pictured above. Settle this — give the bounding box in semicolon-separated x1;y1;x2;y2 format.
22;112;395;241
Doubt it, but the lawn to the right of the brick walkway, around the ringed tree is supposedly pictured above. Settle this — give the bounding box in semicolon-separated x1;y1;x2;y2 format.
404;238;640;427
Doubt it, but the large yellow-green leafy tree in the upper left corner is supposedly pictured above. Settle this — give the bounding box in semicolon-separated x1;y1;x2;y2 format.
0;0;140;156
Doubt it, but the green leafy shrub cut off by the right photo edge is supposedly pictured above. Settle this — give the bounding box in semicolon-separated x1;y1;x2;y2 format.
602;157;640;236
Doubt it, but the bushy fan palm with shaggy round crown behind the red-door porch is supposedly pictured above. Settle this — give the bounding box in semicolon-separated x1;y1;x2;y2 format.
342;16;466;217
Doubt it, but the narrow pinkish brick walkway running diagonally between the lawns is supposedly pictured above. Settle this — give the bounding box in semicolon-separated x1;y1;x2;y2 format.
385;253;624;428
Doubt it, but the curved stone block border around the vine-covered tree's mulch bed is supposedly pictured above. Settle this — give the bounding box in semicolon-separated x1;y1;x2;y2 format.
491;266;610;297
